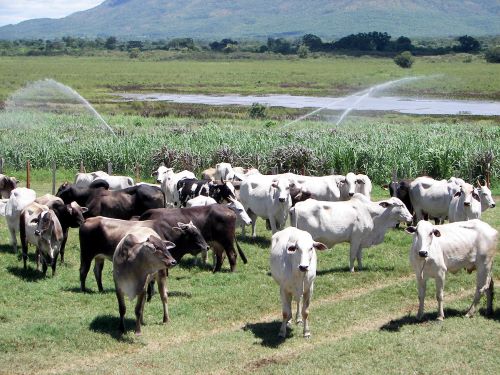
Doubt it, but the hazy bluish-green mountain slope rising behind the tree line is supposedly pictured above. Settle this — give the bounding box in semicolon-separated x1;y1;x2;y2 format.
0;0;500;39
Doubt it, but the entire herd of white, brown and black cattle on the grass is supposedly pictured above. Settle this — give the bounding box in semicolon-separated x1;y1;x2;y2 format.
0;163;497;337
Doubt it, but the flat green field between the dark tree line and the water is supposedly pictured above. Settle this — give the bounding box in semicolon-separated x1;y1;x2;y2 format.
0;54;500;105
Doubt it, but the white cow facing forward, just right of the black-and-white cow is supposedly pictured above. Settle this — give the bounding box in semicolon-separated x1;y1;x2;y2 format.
240;174;294;237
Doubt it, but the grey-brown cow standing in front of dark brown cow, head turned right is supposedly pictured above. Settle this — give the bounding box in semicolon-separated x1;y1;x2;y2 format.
113;228;177;335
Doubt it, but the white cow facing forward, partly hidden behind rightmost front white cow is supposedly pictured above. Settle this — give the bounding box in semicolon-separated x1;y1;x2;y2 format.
448;183;481;223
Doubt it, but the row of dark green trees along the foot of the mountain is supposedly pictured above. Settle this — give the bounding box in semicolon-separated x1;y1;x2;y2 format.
0;31;492;57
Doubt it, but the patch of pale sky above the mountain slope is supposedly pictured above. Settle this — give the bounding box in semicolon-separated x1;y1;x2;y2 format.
0;0;104;26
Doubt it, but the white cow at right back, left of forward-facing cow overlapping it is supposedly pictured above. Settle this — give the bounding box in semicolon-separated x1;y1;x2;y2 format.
410;177;463;222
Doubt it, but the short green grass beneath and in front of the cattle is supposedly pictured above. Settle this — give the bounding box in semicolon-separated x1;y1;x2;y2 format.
0;171;500;374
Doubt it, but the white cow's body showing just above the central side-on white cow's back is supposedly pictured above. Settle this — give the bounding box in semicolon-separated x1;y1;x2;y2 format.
284;173;345;202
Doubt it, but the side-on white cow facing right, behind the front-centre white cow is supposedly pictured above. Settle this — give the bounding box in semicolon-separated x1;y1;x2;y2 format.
290;193;412;272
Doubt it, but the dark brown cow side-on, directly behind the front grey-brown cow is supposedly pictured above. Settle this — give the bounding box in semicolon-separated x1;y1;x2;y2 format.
80;216;208;292
